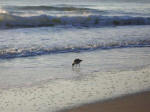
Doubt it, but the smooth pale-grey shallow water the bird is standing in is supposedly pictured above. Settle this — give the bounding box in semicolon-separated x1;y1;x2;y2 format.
0;47;150;88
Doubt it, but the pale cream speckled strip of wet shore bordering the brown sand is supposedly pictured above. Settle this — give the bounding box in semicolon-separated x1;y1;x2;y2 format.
0;68;150;112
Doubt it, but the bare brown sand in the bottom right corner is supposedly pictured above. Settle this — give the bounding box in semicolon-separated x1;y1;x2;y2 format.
64;92;150;112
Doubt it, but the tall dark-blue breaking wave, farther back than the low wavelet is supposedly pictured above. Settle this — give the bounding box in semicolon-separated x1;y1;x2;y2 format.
0;14;150;28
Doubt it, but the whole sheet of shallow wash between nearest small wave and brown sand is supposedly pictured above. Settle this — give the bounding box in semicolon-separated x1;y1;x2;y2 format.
0;48;150;112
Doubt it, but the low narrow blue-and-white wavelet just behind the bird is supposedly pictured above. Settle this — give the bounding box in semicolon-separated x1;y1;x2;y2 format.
0;40;150;59
